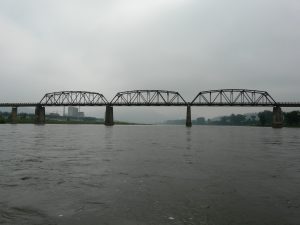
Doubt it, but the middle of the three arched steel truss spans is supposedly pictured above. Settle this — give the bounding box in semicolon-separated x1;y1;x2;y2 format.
110;90;187;106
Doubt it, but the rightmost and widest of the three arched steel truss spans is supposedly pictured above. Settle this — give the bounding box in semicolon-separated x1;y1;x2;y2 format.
191;89;277;106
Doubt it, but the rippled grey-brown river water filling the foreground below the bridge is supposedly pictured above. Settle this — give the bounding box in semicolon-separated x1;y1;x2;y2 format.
0;125;300;225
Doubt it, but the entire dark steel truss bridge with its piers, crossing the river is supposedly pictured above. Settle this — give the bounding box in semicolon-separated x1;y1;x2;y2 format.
0;89;300;127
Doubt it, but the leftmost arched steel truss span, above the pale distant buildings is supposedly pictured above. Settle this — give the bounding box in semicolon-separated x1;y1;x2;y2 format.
39;91;108;106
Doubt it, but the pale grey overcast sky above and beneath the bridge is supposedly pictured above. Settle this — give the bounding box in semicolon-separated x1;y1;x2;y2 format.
0;0;300;123
